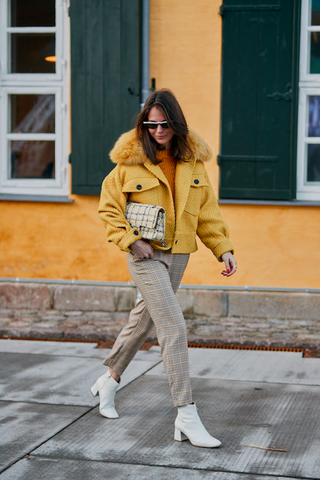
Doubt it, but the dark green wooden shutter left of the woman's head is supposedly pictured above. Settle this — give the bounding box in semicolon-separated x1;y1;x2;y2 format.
70;0;140;195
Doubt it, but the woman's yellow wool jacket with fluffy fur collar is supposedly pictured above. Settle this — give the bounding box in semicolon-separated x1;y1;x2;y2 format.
99;130;233;260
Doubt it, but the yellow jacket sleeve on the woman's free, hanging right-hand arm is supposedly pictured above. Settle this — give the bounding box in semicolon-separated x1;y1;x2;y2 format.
197;171;234;262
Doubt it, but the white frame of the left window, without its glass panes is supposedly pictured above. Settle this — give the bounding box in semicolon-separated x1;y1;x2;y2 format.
0;0;70;196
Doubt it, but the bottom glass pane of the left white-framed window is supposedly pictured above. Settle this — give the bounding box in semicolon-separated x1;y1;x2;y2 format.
11;140;55;178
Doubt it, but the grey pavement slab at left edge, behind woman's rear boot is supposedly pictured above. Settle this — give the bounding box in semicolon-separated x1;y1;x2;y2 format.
0;352;161;406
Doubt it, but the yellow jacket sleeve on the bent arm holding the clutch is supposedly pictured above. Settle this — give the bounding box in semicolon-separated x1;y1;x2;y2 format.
98;166;141;252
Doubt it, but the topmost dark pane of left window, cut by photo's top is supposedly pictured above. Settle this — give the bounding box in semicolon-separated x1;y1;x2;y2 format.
11;0;56;27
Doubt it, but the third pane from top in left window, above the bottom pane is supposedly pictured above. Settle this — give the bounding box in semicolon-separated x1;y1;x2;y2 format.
10;95;55;133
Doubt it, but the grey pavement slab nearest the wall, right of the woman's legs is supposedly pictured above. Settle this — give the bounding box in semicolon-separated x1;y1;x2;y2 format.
149;348;320;385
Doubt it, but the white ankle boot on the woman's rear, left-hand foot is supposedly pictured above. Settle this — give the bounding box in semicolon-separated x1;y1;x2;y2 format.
90;370;120;418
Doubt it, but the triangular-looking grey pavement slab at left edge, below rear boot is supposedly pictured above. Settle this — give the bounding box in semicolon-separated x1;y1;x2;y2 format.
0;401;89;470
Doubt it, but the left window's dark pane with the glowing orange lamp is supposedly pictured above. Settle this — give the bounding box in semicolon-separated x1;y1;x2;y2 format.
11;33;56;73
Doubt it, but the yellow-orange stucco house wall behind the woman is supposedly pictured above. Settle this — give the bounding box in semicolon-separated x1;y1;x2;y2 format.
0;0;320;288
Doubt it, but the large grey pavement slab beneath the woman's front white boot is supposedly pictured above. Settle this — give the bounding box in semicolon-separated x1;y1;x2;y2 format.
32;375;320;480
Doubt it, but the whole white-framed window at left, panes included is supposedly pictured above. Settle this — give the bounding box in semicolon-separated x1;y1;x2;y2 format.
0;0;70;195
